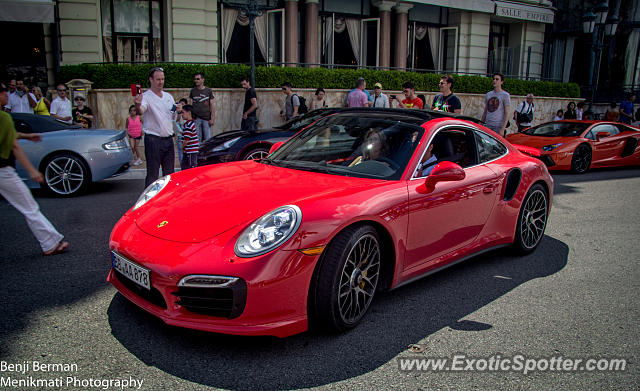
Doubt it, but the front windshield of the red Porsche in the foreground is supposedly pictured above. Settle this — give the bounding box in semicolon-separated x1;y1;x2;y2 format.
261;113;424;180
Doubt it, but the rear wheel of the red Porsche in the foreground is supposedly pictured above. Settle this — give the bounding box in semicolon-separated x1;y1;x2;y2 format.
513;183;549;254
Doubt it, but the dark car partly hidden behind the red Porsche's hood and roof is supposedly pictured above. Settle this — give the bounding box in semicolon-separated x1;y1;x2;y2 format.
198;108;338;166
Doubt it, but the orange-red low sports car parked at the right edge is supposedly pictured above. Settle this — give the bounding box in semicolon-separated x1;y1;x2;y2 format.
507;120;640;173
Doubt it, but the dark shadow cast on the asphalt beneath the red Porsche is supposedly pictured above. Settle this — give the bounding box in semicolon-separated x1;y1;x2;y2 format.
108;236;569;390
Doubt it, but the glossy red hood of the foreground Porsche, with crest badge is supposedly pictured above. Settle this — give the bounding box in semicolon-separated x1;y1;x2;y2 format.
132;161;380;243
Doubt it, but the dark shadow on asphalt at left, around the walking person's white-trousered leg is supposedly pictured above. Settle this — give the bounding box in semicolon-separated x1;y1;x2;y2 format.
0;181;144;357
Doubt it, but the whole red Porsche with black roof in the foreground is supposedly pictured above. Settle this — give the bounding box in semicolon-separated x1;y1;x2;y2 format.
108;109;553;337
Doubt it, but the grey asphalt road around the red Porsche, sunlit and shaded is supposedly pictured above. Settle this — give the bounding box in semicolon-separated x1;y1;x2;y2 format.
0;168;640;390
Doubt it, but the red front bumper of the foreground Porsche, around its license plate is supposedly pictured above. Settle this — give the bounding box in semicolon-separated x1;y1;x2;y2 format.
107;217;318;337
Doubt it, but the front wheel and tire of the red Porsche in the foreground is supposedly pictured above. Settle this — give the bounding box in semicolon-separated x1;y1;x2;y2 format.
309;225;382;331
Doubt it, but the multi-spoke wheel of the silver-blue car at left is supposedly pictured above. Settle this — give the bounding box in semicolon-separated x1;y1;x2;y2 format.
42;154;91;197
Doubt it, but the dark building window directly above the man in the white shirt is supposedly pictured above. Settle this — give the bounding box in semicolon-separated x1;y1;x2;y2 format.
100;0;163;63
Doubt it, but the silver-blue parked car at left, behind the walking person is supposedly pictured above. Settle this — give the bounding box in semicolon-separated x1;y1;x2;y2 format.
11;113;132;196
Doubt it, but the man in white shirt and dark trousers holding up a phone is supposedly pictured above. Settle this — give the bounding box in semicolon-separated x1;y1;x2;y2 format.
134;67;177;186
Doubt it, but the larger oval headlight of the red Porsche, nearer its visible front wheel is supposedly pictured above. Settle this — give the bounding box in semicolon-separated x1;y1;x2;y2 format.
235;205;302;258
